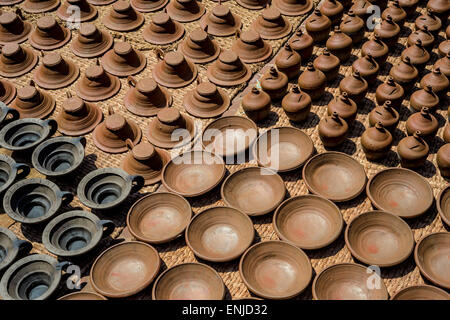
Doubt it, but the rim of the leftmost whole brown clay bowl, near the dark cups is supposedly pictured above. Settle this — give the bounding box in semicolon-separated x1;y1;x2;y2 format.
89;241;161;298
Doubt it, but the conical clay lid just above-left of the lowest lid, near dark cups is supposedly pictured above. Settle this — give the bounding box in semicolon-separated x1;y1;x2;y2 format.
92;107;142;153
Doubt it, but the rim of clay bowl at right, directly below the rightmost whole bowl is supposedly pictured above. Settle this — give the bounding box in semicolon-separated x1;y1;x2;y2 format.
344;210;415;268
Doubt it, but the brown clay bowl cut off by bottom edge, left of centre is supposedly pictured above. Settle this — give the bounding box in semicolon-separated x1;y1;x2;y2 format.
152;263;225;300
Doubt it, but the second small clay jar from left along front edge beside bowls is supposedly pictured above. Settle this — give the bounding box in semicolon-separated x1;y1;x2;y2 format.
281;85;311;122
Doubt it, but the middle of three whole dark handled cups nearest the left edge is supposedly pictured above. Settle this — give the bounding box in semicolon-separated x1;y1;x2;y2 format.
3;178;73;224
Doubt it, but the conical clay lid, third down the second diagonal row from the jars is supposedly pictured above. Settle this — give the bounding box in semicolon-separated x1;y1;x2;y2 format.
231;29;272;63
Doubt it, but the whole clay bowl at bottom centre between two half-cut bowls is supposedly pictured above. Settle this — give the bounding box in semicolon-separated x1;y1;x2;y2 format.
239;241;312;300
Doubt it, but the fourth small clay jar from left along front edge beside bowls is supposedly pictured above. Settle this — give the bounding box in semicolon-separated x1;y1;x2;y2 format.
361;122;393;161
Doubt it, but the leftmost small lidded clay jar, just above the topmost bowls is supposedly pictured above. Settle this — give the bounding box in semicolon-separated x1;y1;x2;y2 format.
242;87;271;122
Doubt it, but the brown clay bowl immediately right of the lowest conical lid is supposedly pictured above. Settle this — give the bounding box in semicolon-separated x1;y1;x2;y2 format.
162;151;226;197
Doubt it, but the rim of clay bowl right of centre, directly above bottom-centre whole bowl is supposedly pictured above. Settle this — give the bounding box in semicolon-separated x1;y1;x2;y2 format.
272;194;344;250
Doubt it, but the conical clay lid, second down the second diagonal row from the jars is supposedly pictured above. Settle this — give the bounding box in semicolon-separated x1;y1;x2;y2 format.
200;3;242;37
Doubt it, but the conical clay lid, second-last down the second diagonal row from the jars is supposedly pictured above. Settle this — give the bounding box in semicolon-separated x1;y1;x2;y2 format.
124;76;172;117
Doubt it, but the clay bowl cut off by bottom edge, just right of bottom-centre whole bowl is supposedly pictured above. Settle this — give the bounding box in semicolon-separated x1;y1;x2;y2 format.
312;263;388;300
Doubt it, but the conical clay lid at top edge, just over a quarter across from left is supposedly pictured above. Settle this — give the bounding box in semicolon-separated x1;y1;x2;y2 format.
102;0;144;32
